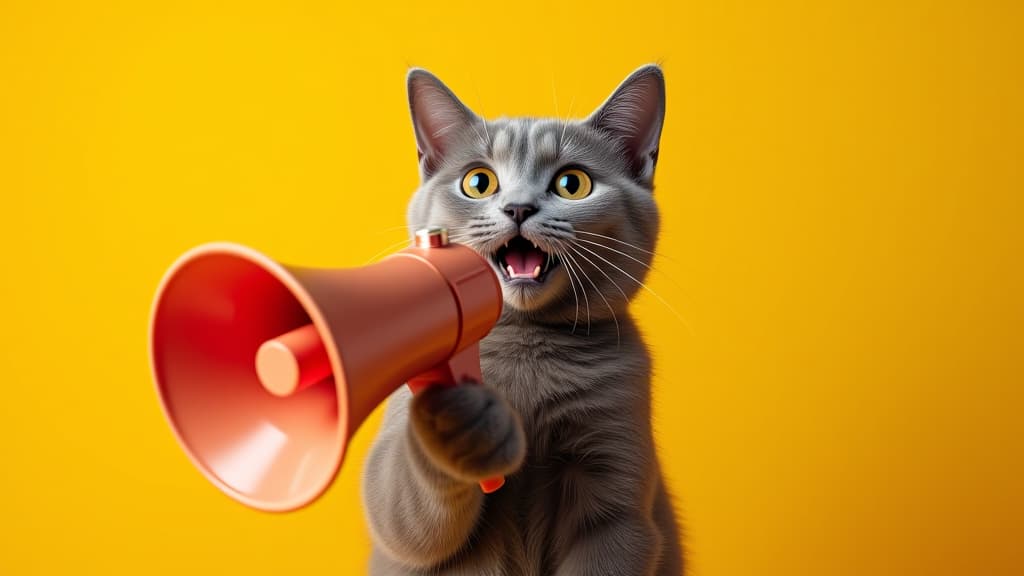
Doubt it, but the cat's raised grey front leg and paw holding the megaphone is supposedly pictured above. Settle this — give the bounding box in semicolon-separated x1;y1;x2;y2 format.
362;384;526;573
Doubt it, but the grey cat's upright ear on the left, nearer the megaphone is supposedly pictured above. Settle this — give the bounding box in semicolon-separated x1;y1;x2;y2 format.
407;68;480;175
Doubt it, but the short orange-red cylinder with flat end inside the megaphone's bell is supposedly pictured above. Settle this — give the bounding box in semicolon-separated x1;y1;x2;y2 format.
256;324;331;397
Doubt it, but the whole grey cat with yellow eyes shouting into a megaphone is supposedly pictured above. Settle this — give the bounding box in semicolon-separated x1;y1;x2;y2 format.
362;66;683;576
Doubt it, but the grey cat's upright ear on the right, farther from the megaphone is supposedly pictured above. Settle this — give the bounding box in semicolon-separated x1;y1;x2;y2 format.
586;65;665;180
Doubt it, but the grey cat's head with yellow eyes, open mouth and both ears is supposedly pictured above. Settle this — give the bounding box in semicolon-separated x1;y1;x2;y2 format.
408;66;665;324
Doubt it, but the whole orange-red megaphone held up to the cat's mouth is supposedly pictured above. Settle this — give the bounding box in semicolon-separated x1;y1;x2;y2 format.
150;230;502;511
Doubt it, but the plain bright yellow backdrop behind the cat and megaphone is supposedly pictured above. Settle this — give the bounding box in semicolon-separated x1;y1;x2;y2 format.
0;0;1024;576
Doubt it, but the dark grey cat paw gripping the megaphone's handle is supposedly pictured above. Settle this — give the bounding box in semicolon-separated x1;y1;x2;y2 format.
411;383;526;482
